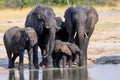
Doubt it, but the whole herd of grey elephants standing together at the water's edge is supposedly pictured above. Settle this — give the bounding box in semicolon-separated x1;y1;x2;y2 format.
3;6;98;69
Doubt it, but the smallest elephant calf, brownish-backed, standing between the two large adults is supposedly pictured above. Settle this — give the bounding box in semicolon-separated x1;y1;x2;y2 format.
52;40;81;68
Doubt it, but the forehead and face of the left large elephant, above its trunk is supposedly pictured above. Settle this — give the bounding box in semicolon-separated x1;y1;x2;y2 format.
33;6;57;28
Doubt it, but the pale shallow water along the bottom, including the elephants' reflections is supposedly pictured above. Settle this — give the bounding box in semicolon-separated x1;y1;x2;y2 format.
0;65;120;80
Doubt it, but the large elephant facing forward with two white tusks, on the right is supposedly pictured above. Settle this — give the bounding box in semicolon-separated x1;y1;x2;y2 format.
64;6;98;66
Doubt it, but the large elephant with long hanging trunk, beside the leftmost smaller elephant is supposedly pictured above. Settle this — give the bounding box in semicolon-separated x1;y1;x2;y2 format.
25;6;57;67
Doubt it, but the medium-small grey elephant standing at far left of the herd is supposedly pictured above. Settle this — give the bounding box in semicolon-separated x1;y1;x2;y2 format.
3;26;39;69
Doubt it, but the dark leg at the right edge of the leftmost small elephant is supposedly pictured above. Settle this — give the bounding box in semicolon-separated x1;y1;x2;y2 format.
33;45;39;69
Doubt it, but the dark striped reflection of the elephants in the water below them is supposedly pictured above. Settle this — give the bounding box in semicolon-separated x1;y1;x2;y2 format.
8;68;88;80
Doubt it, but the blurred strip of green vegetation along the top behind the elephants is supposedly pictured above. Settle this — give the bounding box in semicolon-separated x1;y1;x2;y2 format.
0;0;119;8
